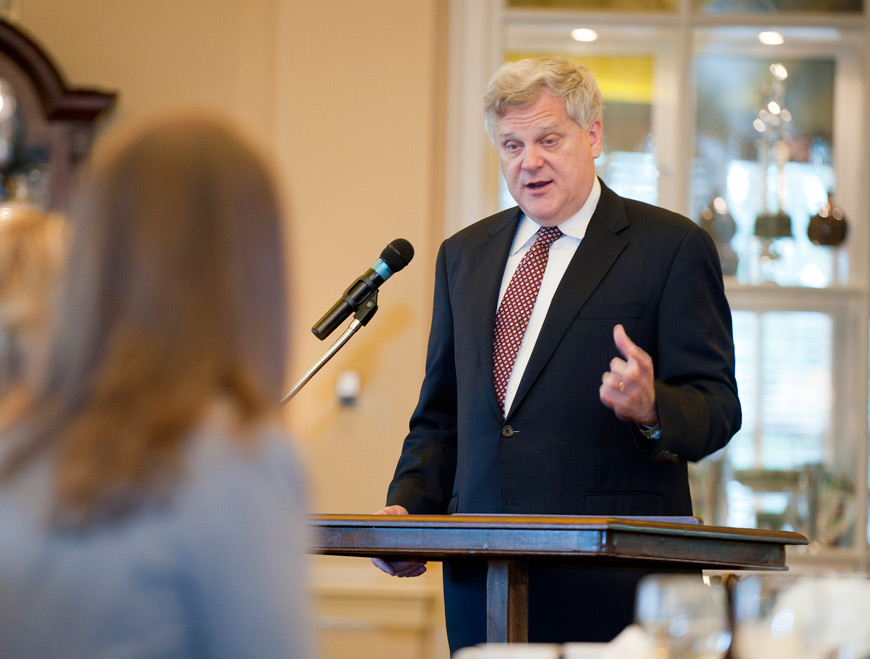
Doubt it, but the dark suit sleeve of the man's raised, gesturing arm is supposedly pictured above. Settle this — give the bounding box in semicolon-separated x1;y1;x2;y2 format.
650;228;741;462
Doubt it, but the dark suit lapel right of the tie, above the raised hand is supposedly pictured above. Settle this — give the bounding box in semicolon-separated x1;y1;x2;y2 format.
508;183;628;418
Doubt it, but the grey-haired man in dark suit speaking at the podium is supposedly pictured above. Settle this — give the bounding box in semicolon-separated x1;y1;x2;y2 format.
374;58;740;651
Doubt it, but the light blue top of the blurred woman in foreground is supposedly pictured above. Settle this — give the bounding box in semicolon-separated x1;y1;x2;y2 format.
0;402;313;659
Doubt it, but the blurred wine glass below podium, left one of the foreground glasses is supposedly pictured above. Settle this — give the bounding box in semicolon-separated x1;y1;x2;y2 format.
635;574;731;659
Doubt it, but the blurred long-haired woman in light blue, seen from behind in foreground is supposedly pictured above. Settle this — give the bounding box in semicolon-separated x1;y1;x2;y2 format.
0;114;312;658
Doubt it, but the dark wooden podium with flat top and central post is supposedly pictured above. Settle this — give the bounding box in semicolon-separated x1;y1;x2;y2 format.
311;515;807;643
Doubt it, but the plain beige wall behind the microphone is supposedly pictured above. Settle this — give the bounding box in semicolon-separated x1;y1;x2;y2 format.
20;0;447;657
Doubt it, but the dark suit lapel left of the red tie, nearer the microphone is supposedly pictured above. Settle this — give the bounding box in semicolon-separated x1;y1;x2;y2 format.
472;208;520;416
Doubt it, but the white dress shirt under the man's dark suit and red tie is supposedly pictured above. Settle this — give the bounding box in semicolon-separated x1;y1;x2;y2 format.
498;176;601;412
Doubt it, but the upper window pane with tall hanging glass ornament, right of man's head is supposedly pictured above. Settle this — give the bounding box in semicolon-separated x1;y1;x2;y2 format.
691;54;845;287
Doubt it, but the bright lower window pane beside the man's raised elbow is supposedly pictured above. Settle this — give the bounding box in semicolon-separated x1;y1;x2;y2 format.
692;311;856;546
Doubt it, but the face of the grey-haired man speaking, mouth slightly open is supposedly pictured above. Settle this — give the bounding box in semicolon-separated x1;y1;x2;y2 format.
495;92;602;227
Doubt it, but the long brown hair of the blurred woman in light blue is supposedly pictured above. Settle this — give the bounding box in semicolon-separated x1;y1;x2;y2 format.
5;113;287;524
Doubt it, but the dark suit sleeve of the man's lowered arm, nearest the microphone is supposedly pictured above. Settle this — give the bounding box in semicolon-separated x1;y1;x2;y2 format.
387;245;456;514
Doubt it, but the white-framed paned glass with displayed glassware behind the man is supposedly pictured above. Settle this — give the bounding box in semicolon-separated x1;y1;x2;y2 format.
494;0;870;564
